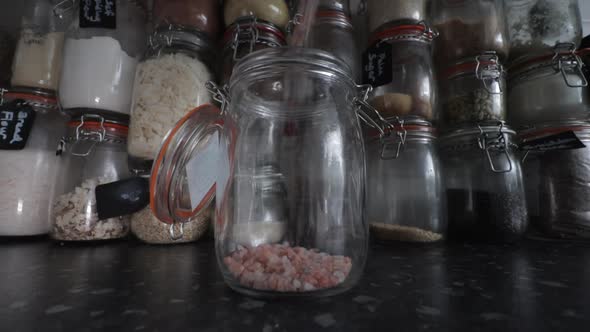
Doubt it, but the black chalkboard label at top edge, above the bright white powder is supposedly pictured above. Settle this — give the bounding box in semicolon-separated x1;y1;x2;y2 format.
80;0;117;29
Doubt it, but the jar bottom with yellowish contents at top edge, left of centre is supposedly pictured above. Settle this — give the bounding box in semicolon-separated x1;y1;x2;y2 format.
223;0;289;29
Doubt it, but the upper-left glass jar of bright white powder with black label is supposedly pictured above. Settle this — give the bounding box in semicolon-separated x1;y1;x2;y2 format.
59;0;146;121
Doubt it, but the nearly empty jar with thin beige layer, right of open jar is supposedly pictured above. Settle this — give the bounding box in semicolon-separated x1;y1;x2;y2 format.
365;118;447;243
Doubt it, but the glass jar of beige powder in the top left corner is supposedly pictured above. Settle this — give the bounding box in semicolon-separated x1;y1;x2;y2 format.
10;0;71;108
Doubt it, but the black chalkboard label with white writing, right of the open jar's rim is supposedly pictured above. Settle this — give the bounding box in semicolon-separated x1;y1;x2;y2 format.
363;43;393;87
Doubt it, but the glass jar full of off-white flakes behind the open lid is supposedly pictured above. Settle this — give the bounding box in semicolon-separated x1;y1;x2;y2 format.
127;28;213;173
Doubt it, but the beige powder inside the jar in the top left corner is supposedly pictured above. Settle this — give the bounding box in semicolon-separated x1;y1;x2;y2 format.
11;29;64;91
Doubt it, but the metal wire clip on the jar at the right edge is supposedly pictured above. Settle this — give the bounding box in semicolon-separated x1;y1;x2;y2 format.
553;43;588;88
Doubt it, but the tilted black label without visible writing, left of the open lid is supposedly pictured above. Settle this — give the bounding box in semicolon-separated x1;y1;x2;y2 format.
94;178;150;220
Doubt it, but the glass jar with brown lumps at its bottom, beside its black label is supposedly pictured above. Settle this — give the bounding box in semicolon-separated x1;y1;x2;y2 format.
364;26;439;122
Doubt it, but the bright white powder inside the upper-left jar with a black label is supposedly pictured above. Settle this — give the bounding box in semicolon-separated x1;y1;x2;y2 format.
59;37;137;114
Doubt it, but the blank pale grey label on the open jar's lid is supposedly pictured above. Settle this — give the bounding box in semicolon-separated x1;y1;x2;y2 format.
186;134;219;210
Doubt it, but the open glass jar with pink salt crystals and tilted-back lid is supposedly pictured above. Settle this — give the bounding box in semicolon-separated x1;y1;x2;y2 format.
150;48;368;297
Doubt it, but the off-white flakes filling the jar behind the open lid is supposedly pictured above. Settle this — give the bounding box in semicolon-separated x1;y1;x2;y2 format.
127;53;211;160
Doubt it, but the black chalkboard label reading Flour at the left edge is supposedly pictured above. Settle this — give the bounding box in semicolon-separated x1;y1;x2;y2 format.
0;100;36;150
